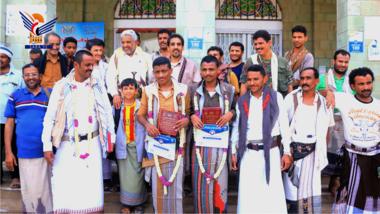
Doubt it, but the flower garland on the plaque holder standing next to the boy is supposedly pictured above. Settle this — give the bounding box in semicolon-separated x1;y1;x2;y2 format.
148;93;186;195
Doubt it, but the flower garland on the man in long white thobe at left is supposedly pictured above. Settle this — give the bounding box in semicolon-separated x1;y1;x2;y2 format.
73;74;92;167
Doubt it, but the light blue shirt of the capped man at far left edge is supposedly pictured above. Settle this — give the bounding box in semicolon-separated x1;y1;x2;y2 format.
0;67;26;124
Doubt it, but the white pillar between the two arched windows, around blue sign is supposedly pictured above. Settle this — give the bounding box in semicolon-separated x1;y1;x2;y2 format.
176;0;215;65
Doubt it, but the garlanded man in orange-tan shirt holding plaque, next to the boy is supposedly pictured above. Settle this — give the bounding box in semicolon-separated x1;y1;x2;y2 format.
137;57;190;213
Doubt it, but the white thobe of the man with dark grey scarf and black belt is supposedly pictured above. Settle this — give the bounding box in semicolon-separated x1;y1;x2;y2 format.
231;92;290;213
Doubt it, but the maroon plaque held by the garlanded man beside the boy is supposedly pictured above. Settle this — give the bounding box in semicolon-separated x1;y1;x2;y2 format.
158;109;180;136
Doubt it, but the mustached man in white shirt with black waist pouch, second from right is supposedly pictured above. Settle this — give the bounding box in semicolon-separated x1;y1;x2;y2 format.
283;67;334;213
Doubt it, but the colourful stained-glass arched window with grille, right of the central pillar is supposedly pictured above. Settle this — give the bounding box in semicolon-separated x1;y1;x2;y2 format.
215;0;282;21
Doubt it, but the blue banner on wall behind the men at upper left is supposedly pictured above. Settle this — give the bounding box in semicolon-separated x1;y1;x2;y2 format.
55;22;104;51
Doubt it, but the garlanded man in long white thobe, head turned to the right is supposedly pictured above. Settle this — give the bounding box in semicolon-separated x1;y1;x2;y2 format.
42;50;115;213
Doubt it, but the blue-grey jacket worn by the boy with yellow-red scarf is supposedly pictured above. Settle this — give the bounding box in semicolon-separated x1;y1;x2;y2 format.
112;99;146;162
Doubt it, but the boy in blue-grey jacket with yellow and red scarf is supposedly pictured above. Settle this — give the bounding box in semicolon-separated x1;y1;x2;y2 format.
114;78;147;213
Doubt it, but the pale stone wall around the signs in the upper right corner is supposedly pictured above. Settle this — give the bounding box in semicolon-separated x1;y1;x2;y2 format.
337;0;380;99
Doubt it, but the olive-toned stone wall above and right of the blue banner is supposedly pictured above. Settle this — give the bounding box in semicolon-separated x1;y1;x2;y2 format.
57;0;119;56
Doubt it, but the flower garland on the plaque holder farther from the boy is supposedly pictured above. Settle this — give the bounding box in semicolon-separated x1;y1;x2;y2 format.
194;93;229;184
